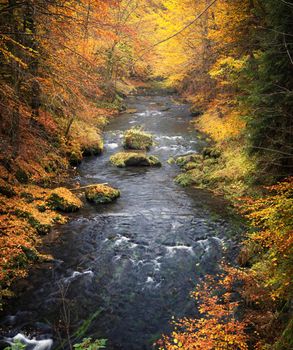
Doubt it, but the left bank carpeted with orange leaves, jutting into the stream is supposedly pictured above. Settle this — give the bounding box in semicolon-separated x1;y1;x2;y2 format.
0;181;82;306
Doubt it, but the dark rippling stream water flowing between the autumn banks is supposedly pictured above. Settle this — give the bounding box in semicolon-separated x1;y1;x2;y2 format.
2;93;239;350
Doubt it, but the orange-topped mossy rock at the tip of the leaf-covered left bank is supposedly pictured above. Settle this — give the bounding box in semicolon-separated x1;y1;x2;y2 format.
46;187;82;213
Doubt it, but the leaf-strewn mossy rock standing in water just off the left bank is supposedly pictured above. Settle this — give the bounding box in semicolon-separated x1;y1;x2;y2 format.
85;184;120;204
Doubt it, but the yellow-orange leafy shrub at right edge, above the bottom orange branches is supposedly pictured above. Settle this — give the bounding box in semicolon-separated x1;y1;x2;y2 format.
241;177;293;300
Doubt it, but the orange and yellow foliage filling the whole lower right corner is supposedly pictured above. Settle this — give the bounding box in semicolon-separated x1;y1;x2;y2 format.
158;178;293;350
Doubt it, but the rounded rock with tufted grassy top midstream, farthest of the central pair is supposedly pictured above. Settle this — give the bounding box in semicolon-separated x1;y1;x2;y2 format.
124;127;154;151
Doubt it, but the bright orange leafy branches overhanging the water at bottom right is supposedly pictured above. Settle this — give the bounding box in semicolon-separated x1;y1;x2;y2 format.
159;275;248;350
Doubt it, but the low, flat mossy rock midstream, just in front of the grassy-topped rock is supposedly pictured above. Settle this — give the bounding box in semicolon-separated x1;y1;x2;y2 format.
110;152;162;168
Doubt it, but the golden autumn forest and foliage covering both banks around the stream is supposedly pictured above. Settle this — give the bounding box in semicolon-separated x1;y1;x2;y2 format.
0;0;293;350
